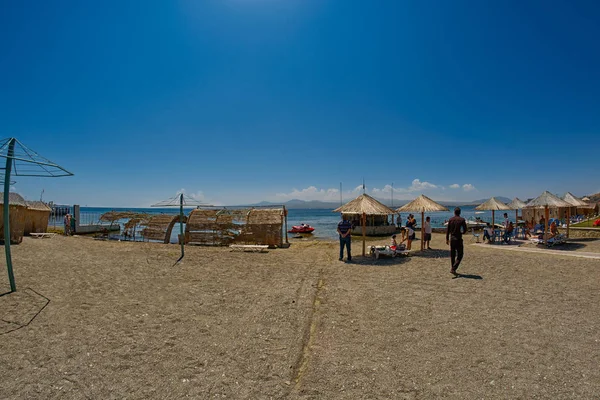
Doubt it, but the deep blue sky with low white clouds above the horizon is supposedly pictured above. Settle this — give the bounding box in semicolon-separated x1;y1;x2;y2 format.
0;0;600;207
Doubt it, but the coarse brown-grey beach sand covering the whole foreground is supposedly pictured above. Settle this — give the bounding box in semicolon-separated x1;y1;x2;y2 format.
0;234;600;399
